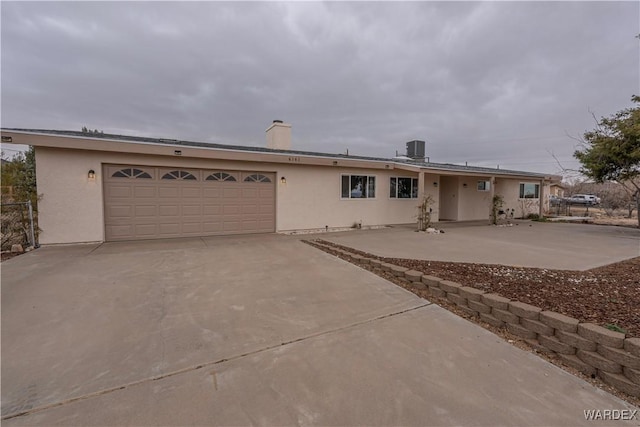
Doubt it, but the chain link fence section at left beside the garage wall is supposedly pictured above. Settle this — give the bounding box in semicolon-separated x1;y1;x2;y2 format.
0;201;38;251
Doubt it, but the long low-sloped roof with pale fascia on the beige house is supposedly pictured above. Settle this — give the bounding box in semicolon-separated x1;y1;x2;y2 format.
2;128;561;181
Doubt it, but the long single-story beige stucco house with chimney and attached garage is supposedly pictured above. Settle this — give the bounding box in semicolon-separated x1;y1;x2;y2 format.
2;121;560;244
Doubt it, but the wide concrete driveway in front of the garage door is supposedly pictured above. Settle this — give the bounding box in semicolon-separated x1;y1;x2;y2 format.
2;235;637;426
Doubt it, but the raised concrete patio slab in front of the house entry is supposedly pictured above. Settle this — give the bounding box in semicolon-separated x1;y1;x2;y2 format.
322;221;640;270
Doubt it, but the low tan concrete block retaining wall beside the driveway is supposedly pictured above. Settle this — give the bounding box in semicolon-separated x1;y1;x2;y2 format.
330;248;640;397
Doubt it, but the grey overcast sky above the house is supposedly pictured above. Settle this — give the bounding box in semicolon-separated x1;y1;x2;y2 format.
1;1;640;173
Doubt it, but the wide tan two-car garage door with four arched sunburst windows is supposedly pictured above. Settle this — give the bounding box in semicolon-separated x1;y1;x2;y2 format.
103;165;275;241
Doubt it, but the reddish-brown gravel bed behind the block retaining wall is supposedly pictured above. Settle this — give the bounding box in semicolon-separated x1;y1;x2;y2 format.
312;241;640;337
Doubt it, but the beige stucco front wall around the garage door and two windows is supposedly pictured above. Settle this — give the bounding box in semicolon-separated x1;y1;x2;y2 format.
36;147;430;244
